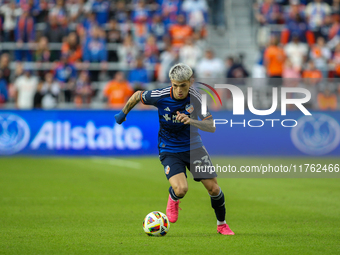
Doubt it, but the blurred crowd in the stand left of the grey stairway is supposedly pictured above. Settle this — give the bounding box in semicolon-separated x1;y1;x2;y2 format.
0;0;225;109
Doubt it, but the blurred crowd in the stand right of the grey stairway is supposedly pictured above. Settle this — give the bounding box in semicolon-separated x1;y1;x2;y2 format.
253;0;340;110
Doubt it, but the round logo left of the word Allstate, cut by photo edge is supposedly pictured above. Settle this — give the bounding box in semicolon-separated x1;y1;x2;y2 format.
0;114;30;155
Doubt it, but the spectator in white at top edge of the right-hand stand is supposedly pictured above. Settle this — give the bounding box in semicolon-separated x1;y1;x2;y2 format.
305;0;331;31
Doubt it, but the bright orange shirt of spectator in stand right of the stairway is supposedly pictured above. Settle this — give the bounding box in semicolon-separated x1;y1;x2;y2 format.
264;46;286;76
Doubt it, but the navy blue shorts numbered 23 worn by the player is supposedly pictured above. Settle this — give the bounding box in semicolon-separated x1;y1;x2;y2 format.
159;146;217;181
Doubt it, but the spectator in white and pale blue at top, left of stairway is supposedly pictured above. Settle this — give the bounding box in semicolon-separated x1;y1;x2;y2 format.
182;0;208;30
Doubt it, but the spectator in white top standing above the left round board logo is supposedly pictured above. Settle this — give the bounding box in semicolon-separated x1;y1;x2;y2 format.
14;69;38;109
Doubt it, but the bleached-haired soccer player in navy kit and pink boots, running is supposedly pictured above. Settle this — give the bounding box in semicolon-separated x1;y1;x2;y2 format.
115;63;234;235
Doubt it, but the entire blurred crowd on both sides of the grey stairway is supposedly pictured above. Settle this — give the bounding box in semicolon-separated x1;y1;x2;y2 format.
0;0;340;109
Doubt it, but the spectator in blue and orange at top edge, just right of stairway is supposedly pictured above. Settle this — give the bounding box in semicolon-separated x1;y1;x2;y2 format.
256;0;282;25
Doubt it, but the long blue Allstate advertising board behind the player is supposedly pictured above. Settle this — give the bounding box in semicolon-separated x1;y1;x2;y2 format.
0;110;340;156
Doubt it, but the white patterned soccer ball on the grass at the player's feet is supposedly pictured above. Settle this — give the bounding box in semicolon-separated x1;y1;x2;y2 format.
143;211;170;236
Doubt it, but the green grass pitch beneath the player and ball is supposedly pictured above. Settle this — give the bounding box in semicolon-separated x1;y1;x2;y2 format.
0;157;340;255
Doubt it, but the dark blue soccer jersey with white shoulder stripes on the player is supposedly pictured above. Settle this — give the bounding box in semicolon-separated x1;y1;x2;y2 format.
141;87;212;153
